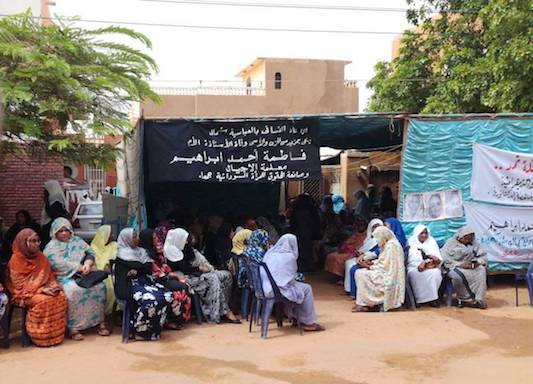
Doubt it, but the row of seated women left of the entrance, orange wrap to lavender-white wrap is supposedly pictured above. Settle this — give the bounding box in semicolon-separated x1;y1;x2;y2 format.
0;210;324;346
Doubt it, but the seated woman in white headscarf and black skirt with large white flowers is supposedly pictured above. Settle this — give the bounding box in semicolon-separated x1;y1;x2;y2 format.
115;228;172;340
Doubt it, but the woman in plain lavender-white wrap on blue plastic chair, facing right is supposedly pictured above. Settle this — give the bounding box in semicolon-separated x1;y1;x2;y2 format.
261;234;325;332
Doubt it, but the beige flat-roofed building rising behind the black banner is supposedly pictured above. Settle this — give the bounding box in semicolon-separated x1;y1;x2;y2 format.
140;58;359;118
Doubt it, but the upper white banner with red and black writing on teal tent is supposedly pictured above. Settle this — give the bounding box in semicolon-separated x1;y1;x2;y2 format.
471;143;533;207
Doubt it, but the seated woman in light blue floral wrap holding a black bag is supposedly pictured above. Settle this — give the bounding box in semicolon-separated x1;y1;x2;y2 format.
44;217;109;340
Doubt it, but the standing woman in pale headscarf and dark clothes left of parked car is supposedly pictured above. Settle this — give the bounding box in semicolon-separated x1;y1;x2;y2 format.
40;180;70;247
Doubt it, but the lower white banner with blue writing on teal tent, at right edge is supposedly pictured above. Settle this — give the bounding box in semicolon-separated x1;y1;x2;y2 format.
464;202;533;262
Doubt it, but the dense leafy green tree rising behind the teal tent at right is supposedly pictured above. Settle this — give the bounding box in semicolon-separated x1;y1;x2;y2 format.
367;0;533;113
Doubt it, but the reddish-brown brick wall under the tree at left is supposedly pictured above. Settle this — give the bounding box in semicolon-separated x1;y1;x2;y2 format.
0;155;63;226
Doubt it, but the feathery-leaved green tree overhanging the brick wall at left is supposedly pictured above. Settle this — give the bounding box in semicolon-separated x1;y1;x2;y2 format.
0;12;159;165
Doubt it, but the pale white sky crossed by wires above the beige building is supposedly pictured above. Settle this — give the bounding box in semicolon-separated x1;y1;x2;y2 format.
10;0;409;111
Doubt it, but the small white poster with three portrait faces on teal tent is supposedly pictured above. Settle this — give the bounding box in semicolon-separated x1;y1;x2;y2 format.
402;189;463;222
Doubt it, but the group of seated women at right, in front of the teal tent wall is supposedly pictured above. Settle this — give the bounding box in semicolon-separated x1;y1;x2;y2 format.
324;191;487;312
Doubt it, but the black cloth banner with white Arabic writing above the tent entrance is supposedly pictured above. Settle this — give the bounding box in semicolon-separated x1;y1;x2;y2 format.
144;119;320;183
